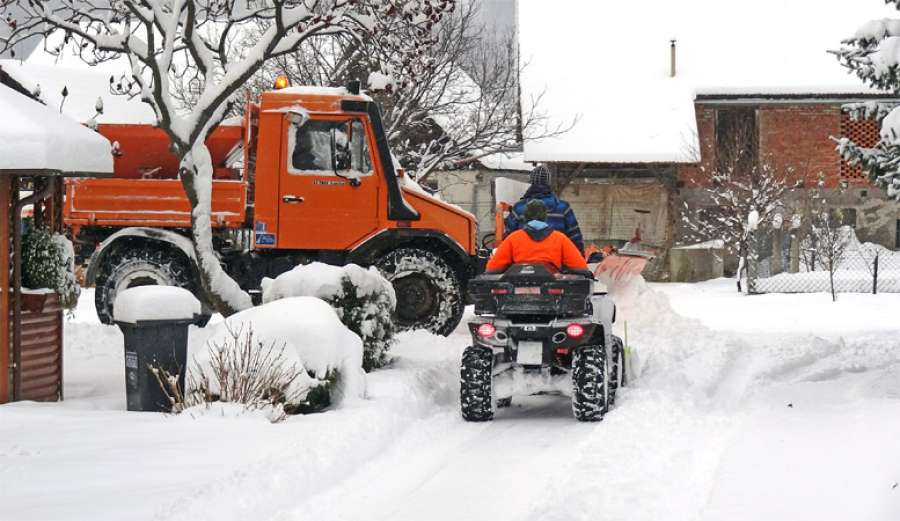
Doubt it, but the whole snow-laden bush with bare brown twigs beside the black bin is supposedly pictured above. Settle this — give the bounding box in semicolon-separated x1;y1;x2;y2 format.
185;297;365;419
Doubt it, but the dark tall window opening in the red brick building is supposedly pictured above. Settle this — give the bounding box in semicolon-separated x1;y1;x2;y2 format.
716;107;759;175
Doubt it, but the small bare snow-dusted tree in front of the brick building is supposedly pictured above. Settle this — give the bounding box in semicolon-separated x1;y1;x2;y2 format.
681;123;796;278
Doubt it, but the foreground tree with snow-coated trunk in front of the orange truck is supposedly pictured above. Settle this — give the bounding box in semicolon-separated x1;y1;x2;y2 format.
0;0;456;314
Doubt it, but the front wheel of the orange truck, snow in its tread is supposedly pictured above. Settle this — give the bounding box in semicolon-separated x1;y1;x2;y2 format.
375;248;463;336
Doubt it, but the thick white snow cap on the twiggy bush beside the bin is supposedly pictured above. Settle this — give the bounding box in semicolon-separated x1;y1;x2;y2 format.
190;297;366;398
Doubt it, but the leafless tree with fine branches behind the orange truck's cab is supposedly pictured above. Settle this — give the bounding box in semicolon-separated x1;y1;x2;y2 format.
195;2;574;181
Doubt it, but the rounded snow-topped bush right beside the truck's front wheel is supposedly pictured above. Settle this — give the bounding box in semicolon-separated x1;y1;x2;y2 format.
262;262;397;371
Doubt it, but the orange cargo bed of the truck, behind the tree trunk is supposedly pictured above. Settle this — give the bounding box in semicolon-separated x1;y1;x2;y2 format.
64;125;247;228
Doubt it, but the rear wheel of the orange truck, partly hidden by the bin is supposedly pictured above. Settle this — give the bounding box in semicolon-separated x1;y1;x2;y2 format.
94;245;212;327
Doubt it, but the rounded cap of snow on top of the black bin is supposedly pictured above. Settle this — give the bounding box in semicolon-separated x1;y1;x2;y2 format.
113;286;200;324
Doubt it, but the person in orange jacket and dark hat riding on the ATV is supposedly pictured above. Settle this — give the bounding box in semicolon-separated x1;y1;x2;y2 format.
486;199;587;272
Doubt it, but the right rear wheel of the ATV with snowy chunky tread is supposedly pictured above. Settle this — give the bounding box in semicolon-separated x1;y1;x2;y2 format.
572;346;608;421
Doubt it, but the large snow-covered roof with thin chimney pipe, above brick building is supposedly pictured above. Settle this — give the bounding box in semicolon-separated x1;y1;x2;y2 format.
519;0;897;163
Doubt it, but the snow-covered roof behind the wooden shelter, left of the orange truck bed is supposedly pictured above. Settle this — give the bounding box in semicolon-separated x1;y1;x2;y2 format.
0;58;156;123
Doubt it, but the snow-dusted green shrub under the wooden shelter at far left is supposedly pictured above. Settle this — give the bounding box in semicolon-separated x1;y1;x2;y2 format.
22;227;81;309
